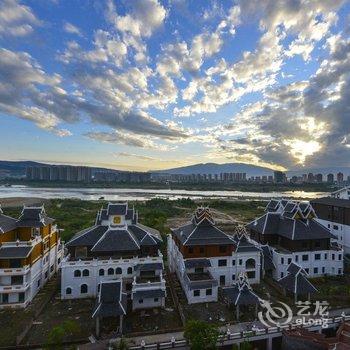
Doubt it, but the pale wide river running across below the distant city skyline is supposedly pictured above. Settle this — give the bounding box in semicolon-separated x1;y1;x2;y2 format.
0;185;327;201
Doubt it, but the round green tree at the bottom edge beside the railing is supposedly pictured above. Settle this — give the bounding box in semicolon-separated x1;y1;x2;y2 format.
184;320;219;350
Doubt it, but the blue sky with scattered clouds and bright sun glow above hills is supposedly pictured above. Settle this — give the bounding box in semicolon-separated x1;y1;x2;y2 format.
0;0;350;171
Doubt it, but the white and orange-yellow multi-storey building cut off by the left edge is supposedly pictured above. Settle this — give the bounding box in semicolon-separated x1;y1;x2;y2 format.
0;207;63;309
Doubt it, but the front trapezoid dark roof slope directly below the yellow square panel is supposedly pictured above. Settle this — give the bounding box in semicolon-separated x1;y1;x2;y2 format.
91;228;140;252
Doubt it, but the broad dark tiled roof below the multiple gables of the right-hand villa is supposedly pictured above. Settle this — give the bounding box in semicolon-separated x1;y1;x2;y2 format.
247;213;334;240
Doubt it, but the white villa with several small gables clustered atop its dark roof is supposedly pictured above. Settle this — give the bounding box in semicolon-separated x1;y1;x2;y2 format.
247;200;344;280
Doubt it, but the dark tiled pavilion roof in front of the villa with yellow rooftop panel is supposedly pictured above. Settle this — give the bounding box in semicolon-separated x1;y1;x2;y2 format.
92;281;127;318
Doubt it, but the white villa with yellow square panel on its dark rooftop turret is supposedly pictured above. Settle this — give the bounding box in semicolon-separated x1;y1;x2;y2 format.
61;203;166;317
